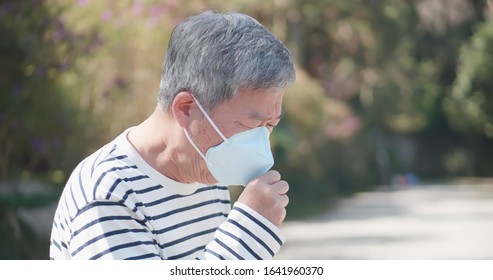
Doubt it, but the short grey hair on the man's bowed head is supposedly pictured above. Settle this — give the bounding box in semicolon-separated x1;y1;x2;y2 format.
158;11;295;110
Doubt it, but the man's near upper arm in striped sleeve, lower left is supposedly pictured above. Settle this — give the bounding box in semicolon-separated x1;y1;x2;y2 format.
69;200;161;259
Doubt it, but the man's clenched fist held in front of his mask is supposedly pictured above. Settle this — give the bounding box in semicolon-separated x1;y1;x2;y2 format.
238;170;289;227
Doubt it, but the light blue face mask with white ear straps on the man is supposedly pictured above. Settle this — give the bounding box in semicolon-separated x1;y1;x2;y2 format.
184;98;274;186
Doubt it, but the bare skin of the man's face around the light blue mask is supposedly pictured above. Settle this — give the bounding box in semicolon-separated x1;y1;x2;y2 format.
191;89;284;183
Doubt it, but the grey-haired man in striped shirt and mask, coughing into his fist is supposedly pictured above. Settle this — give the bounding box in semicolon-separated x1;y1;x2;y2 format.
50;12;295;259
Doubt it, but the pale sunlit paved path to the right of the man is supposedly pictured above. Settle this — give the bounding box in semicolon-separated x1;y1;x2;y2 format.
276;183;493;260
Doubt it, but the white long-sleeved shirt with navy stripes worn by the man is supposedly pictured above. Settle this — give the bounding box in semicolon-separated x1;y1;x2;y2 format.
50;130;284;260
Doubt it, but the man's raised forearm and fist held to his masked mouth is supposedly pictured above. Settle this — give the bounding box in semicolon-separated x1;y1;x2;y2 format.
197;170;289;259
